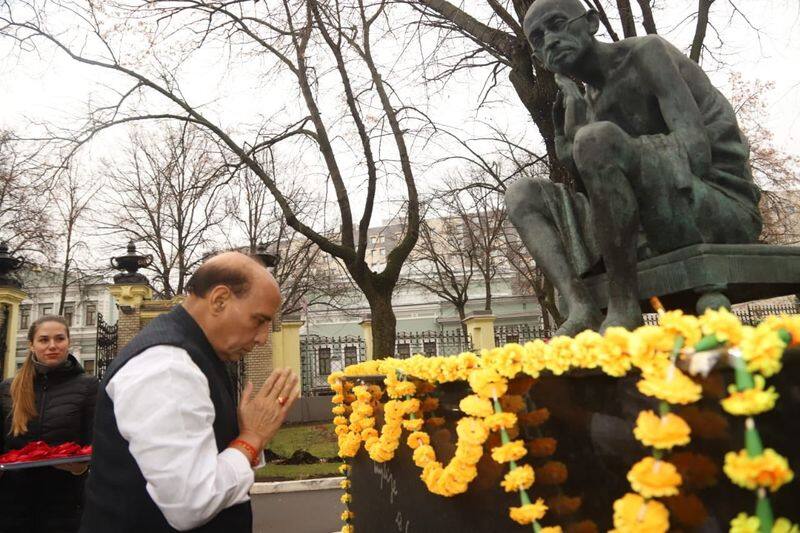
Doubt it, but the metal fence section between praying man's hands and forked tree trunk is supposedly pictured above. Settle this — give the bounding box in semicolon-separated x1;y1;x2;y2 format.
300;335;367;396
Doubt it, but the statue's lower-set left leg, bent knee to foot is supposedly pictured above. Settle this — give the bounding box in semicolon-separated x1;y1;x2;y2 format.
506;179;602;336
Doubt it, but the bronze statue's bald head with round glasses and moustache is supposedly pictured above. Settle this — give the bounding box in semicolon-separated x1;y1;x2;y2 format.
523;0;600;74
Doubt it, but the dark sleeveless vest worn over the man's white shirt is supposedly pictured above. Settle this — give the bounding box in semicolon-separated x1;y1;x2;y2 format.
80;305;252;533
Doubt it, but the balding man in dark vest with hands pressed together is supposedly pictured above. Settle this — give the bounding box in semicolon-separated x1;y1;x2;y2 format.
79;253;298;533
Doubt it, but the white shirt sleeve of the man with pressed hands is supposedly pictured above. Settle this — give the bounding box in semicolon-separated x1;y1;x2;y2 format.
106;345;253;531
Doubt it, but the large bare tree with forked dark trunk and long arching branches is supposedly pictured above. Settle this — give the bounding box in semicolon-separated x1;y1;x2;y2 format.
0;0;425;356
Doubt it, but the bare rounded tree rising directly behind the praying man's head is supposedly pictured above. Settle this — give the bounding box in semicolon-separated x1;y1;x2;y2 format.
97;124;227;298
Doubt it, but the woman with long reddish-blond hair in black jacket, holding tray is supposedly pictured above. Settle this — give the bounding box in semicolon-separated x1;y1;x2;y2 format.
0;316;98;533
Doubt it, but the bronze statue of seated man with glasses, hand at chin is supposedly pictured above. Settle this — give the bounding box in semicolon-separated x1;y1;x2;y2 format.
506;0;761;335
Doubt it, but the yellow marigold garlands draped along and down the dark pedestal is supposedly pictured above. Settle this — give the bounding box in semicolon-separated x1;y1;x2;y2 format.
329;310;800;531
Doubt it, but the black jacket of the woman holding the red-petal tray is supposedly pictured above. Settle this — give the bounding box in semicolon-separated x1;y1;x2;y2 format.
0;355;98;533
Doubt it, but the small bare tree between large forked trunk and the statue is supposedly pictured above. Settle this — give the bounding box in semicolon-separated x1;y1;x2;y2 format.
406;207;476;336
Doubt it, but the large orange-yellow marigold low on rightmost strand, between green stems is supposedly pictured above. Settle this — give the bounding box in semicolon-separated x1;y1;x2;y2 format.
723;448;794;492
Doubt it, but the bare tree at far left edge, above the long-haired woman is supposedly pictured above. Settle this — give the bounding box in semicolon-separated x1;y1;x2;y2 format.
0;131;54;263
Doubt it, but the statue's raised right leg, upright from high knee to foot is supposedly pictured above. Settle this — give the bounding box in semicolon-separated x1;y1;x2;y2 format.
573;122;643;331
